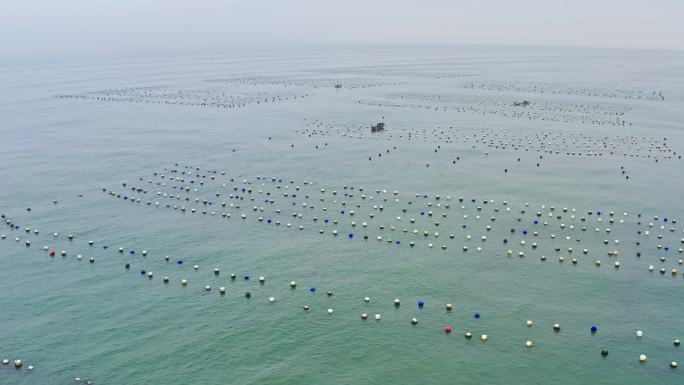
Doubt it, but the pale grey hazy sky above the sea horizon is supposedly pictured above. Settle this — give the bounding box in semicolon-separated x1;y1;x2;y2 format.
0;0;684;60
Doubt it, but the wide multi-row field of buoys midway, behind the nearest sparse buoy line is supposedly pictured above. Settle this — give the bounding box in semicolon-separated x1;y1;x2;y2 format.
91;162;683;275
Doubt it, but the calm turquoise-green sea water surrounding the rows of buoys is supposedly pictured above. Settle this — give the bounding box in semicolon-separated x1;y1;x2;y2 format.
0;47;684;384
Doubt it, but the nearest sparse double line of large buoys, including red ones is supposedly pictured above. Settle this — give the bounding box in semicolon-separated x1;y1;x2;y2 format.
1;213;679;368
